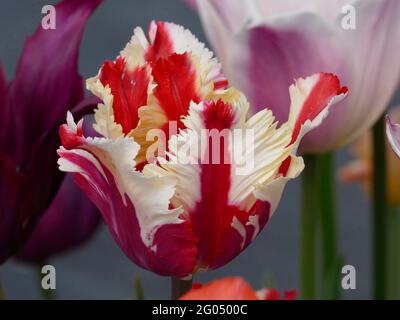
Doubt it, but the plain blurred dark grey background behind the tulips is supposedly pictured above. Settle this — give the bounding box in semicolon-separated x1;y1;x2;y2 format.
0;0;400;299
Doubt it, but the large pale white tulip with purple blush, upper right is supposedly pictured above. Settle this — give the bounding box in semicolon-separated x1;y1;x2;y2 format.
187;0;400;153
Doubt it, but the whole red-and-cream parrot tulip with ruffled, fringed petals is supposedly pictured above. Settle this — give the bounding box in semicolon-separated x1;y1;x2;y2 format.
58;22;347;278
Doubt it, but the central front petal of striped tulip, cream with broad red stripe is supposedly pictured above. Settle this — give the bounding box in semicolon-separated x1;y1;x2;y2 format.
143;89;291;270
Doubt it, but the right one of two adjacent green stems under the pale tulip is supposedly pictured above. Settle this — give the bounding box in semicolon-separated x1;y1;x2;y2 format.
315;152;340;300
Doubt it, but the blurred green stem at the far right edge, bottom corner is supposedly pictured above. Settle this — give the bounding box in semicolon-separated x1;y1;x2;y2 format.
386;208;400;300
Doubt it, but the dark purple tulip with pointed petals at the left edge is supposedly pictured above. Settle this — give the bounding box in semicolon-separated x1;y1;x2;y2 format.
0;0;100;263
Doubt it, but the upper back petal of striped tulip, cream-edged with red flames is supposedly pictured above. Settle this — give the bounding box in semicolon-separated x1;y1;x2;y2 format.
87;21;227;163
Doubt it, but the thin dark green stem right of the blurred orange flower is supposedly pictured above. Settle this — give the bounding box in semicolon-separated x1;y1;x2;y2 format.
372;117;388;300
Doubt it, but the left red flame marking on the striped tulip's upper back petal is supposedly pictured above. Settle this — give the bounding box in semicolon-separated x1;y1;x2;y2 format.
99;57;150;134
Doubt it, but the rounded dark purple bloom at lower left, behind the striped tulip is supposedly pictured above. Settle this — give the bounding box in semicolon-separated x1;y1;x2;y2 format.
17;176;100;263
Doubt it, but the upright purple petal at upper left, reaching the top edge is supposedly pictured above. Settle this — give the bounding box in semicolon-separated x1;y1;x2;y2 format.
10;0;101;162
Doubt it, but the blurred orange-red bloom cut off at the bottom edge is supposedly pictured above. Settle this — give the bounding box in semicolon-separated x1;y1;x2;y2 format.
180;277;297;300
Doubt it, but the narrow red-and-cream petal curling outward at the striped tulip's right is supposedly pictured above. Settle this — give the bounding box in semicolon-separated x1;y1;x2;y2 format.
254;73;348;214
